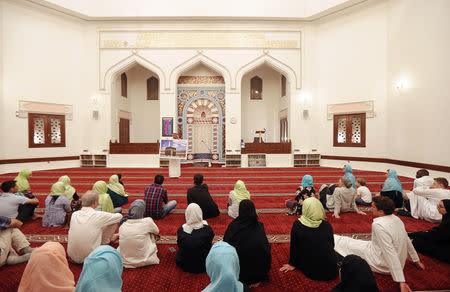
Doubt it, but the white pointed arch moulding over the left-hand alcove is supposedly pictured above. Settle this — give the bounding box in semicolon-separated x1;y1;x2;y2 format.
101;53;166;91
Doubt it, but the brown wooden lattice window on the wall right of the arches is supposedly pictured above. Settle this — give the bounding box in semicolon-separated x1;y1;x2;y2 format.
333;113;366;147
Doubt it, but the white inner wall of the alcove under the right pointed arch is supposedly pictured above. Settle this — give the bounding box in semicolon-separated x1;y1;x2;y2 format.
241;65;281;142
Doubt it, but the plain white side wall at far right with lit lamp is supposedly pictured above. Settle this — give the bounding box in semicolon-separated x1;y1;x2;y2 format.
386;0;450;166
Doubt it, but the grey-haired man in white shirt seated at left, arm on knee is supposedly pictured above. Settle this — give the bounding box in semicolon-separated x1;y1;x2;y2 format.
67;191;122;263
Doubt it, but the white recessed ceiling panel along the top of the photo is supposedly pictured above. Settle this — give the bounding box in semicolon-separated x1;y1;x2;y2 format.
28;0;367;20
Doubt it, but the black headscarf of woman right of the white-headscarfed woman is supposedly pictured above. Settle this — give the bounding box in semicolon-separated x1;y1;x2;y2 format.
223;200;259;242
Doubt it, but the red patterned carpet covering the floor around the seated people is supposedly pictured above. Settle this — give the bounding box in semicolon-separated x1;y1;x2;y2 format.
0;167;450;291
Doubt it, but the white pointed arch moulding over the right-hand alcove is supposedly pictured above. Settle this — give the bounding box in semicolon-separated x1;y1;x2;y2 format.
235;53;300;91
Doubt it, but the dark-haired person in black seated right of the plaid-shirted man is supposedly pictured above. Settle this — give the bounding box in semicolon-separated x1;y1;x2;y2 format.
187;174;220;219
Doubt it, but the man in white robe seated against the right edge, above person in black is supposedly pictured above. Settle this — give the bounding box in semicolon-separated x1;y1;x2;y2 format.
406;177;450;223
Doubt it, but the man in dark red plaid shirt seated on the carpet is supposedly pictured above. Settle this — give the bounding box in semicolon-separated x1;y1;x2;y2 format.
144;174;177;219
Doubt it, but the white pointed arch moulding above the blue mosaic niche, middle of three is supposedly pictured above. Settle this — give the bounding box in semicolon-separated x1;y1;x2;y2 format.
166;52;231;91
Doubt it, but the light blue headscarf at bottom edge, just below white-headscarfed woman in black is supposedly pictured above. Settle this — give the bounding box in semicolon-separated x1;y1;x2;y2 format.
203;241;244;292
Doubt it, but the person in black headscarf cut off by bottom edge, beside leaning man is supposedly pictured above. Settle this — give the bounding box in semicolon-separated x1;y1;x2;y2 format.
331;254;379;292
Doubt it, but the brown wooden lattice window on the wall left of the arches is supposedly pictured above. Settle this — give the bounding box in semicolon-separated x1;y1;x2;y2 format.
28;113;66;148
